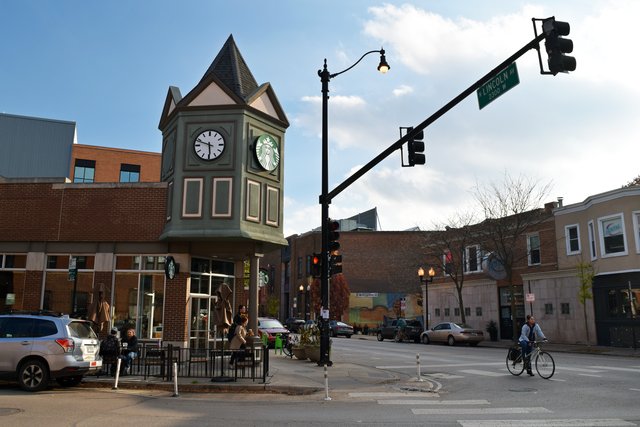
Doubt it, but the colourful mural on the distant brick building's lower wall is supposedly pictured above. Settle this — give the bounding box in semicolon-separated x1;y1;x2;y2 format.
347;292;422;327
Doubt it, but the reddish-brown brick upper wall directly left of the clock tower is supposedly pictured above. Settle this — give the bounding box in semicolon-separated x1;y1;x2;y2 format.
0;183;167;242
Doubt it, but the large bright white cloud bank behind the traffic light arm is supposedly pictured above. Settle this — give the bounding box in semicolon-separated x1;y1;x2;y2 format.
290;0;640;231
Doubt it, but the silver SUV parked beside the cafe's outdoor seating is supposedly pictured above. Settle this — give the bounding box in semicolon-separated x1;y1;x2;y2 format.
0;312;102;391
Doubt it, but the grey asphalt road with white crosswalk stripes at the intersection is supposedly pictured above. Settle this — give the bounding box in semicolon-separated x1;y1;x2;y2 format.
0;338;640;427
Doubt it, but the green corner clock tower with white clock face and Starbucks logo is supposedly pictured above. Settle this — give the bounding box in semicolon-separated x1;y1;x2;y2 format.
159;36;289;330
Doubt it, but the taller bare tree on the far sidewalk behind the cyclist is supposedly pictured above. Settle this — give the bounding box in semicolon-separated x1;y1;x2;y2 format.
473;172;552;340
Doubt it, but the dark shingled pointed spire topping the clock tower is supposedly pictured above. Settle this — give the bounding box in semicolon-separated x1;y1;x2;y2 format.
201;35;258;100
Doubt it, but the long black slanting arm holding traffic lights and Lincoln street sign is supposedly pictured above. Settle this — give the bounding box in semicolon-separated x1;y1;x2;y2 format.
320;33;546;204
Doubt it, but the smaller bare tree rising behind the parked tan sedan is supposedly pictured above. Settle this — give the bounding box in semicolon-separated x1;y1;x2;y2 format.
424;213;480;324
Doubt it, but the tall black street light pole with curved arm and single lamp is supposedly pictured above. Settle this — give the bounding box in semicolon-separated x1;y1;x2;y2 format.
318;49;391;366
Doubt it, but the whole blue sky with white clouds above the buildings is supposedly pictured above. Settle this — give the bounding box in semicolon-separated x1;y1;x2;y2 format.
0;0;640;236
